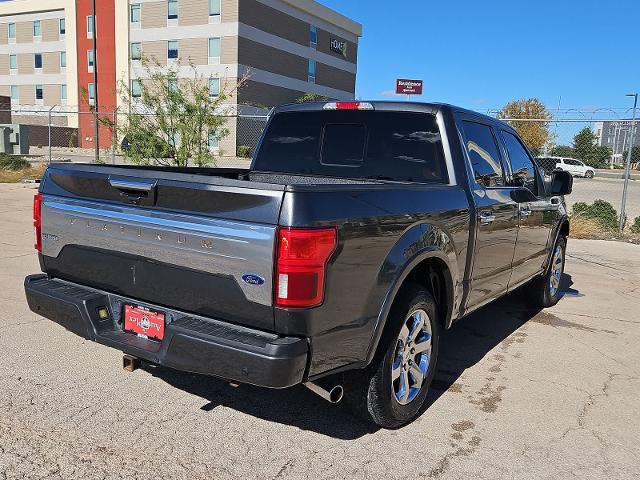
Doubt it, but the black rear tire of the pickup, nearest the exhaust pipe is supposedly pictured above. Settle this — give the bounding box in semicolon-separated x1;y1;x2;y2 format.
345;284;440;429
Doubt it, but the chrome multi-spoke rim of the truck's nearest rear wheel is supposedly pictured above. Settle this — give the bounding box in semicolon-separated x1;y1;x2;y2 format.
391;310;432;405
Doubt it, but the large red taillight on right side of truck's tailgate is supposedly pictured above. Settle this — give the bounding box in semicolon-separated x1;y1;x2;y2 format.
275;228;337;308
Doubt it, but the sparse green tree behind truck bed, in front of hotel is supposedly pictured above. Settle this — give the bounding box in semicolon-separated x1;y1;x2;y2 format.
103;59;246;167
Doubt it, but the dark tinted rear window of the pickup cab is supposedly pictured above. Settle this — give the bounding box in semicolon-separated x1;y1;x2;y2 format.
253;111;448;183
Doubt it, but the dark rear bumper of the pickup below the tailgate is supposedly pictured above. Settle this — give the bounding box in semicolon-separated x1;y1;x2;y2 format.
24;275;309;388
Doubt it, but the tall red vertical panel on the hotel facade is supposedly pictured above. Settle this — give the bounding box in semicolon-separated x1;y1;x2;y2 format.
76;0;117;148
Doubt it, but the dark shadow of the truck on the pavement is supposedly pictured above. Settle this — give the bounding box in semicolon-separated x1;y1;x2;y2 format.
142;275;572;440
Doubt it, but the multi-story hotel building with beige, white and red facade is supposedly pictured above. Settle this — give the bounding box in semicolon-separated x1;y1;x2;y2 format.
0;0;362;154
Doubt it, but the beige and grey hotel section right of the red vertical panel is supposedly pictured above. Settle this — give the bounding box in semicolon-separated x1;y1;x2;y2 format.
127;0;362;152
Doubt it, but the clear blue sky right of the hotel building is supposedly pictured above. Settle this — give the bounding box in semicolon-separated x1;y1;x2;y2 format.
320;0;640;111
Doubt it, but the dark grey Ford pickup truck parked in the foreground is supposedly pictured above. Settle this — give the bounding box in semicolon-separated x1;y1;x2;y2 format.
25;102;572;428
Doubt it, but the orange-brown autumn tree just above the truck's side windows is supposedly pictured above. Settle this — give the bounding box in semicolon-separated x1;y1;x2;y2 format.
498;98;552;155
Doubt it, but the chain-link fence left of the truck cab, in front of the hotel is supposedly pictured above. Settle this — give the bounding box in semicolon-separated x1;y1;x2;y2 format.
0;106;268;168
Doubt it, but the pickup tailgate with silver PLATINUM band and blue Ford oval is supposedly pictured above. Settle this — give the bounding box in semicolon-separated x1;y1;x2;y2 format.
40;166;284;330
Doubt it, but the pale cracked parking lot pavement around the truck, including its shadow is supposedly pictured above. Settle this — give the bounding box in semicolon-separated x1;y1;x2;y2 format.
0;182;640;480
